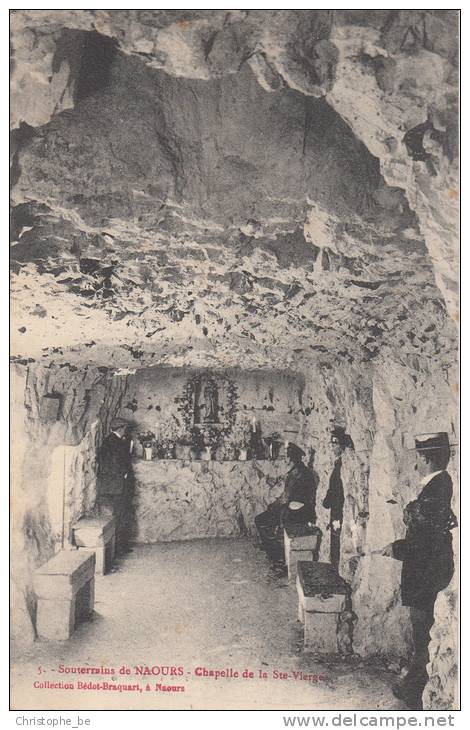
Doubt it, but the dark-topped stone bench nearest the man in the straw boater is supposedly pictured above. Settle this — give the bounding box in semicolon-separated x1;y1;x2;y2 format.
297;561;350;654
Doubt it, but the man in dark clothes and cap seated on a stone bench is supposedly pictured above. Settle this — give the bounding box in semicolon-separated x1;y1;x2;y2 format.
255;443;317;562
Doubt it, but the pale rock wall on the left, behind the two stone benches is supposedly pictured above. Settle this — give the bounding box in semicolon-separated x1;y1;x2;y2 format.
11;365;126;651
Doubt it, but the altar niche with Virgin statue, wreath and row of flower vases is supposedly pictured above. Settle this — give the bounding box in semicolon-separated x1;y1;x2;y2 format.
119;367;306;461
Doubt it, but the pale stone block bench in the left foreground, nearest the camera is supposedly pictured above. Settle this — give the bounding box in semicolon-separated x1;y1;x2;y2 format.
34;550;95;641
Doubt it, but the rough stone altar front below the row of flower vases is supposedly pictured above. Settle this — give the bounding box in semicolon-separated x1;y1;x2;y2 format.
133;459;288;543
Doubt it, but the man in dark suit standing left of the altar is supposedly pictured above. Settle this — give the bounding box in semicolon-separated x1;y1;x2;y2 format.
98;418;131;554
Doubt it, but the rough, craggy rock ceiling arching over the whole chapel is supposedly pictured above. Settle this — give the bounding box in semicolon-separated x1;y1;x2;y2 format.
11;10;457;368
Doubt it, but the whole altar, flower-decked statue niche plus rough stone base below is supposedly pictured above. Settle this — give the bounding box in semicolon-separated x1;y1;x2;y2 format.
120;368;303;543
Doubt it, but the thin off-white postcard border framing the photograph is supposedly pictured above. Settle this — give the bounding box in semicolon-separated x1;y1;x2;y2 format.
0;2;470;730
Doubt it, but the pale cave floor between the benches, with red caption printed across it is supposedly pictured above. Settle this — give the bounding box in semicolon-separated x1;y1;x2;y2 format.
12;539;404;711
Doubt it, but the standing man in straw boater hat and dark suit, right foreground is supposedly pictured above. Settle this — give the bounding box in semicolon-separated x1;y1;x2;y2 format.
382;432;457;710
